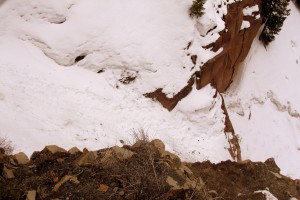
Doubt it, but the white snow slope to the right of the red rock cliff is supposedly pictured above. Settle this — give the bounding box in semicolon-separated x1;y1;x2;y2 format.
225;3;300;178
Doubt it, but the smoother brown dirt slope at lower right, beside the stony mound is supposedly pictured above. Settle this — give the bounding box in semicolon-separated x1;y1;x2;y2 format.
189;159;300;200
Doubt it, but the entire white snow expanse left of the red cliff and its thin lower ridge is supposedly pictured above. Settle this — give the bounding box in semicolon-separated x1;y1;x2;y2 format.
0;0;230;162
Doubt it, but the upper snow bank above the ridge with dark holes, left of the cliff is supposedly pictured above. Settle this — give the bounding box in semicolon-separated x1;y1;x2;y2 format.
1;0;232;97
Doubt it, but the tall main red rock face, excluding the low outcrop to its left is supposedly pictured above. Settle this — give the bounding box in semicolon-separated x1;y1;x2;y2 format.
196;0;262;92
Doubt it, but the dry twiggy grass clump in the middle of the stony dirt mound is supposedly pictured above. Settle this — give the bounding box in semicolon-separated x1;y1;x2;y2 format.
105;141;170;200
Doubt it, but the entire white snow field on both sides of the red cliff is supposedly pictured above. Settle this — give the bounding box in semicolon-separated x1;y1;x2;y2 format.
0;0;300;178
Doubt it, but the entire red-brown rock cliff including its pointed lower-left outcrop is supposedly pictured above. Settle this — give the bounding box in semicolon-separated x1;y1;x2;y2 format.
145;0;262;111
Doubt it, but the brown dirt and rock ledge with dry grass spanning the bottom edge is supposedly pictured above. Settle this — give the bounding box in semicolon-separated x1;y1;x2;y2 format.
0;140;300;200
